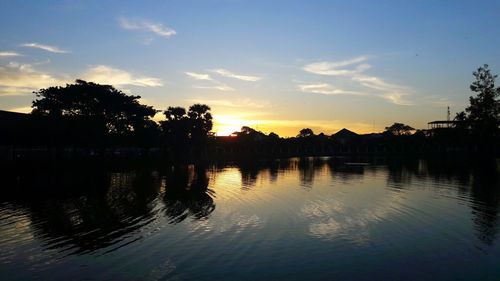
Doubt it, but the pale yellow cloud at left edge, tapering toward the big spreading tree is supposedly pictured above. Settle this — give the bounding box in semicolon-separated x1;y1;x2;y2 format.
0;62;69;96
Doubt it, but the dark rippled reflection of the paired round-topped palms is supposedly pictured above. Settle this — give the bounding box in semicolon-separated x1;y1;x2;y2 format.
164;165;215;223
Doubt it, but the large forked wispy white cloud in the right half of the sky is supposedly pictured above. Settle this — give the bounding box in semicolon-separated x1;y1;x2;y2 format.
298;56;413;105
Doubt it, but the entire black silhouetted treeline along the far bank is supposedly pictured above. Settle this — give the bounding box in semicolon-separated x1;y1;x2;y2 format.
0;65;500;158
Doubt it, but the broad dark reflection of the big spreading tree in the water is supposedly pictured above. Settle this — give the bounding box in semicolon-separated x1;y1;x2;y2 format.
0;166;160;254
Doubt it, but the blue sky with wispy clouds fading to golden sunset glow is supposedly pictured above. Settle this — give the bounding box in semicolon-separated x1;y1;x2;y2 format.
0;0;500;136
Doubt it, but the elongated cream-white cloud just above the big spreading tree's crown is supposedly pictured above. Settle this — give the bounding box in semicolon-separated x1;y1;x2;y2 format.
82;65;163;87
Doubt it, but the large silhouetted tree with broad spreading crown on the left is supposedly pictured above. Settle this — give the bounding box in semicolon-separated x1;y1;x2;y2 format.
32;80;156;134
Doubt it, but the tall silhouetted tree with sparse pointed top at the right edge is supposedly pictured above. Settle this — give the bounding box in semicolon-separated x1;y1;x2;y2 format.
457;64;500;135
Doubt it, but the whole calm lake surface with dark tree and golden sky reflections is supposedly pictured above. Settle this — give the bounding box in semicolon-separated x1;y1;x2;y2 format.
0;158;500;280
